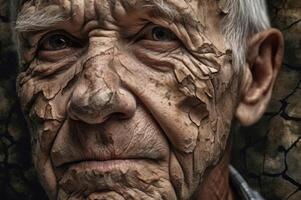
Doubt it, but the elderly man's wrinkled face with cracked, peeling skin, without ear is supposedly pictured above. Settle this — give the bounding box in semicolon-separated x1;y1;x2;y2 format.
17;0;246;199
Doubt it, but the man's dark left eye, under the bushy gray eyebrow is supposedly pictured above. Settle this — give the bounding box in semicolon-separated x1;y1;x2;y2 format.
39;33;81;51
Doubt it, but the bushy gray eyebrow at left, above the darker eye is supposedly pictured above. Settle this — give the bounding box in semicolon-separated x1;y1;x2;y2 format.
15;5;68;33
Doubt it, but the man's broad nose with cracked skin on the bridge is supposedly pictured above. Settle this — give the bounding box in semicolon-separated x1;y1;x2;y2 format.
67;56;136;124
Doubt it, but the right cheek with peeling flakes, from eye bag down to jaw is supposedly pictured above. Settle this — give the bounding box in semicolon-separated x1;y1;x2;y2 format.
113;44;234;196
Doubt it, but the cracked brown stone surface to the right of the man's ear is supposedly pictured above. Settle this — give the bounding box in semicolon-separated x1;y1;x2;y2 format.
232;0;301;200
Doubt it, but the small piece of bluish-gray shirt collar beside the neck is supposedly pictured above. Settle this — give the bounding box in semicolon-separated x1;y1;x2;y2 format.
229;166;264;200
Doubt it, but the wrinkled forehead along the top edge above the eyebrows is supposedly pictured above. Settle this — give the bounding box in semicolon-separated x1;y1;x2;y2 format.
16;0;223;25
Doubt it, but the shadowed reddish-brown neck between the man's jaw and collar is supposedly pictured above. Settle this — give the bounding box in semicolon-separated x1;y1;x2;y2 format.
192;145;236;200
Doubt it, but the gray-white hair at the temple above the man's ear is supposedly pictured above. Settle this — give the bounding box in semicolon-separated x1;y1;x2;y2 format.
11;0;271;72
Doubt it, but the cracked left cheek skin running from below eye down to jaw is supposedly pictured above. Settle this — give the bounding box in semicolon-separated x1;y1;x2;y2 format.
18;60;79;198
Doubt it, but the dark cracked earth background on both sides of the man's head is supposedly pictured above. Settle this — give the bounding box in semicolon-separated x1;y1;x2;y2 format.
0;0;301;200
